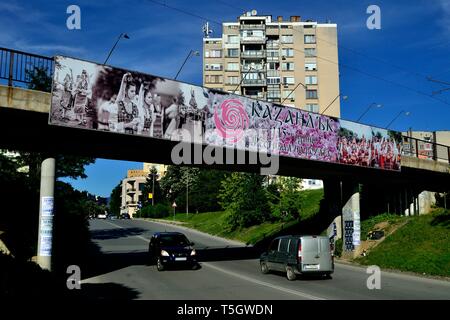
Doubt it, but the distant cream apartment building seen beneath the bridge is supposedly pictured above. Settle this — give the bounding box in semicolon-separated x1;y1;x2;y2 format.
120;163;167;217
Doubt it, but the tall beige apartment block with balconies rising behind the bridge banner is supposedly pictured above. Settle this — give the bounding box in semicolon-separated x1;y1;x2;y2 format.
203;10;340;117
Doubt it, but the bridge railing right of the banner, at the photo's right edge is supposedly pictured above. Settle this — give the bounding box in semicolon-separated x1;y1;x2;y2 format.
402;136;450;164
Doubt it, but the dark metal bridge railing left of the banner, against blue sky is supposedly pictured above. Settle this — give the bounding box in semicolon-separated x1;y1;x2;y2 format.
0;47;54;87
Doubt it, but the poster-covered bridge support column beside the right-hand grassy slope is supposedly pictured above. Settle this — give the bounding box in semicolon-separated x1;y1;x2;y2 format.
342;181;361;259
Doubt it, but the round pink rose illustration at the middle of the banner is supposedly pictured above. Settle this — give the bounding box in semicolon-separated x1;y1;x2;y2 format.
214;99;249;143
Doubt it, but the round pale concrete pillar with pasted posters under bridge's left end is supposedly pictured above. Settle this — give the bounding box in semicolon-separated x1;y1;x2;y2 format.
37;158;55;271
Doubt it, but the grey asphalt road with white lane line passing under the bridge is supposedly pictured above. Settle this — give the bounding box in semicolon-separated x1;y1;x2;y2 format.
81;220;450;300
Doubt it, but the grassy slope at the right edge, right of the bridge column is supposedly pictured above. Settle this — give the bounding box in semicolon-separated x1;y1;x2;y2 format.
356;209;450;277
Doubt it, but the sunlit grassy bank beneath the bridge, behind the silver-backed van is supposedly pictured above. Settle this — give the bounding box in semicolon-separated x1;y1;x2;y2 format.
161;189;323;244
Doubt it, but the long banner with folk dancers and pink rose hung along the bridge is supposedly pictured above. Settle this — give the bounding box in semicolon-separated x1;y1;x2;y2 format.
49;56;401;170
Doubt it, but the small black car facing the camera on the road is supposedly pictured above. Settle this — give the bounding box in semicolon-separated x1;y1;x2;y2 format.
148;232;198;271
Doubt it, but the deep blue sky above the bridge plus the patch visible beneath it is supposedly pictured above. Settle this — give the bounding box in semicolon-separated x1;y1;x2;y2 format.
0;0;450;196
